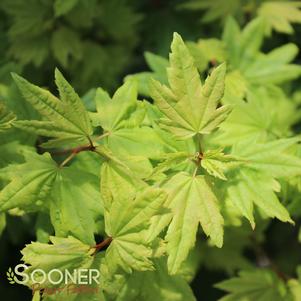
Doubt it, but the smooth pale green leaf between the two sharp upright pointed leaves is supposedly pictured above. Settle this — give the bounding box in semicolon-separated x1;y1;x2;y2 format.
91;80;164;164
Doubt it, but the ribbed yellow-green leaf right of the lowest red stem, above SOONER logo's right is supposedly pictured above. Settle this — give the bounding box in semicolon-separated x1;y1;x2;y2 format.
104;188;166;273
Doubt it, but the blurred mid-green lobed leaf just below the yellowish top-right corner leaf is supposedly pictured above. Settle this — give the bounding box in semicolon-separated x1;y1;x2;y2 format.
222;18;301;85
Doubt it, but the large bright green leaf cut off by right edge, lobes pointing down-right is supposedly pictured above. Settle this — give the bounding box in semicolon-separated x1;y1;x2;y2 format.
227;138;301;227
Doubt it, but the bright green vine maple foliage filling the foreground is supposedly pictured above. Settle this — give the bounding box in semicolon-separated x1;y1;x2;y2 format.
0;19;301;301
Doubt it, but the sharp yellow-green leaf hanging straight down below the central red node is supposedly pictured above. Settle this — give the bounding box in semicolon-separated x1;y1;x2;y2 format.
158;172;224;274
